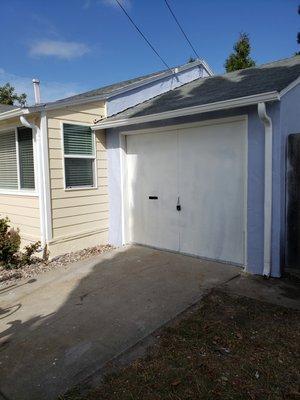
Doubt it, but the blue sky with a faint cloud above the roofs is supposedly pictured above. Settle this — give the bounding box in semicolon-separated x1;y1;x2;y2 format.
0;0;300;102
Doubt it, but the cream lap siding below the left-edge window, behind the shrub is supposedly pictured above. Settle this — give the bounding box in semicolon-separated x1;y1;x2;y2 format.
0;194;40;241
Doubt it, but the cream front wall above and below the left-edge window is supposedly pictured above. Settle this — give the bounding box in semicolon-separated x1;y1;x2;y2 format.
0;116;41;246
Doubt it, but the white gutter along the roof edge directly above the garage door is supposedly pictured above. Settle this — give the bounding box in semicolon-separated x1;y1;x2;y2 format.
91;91;280;130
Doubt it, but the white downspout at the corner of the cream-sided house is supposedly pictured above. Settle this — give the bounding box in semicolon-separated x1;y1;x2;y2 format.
20;113;52;255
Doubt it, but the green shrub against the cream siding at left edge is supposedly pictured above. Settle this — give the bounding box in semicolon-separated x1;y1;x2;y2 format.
0;217;40;269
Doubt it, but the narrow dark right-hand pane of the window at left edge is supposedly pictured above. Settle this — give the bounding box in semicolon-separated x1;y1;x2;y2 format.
18;128;35;189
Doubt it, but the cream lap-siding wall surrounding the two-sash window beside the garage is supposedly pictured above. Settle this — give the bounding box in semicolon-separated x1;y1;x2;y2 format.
47;102;108;257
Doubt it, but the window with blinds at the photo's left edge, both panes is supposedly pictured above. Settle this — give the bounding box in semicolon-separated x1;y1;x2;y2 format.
0;128;35;190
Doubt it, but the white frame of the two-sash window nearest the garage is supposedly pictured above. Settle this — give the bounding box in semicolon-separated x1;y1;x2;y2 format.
60;121;98;192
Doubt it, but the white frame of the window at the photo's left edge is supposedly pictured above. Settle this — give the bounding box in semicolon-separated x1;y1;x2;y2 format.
0;125;38;197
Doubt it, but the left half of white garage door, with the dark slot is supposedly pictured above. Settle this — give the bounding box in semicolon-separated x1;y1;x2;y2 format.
127;133;179;251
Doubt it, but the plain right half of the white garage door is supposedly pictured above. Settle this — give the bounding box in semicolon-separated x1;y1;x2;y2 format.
179;122;245;264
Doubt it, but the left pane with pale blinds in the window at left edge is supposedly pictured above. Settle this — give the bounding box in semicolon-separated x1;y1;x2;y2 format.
0;131;18;189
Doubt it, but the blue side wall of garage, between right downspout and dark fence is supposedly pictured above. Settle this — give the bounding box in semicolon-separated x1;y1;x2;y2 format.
279;84;300;266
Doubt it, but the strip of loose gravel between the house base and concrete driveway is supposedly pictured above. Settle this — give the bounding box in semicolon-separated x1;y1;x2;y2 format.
0;245;114;285
